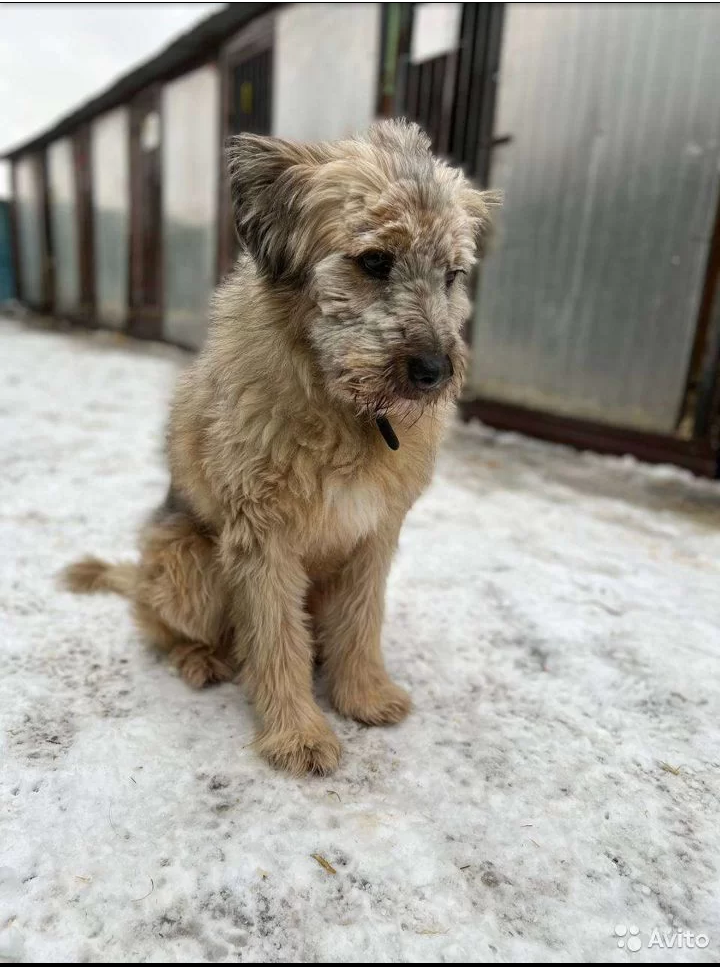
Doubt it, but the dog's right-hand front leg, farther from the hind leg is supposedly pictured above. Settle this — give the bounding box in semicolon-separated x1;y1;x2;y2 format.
316;526;411;725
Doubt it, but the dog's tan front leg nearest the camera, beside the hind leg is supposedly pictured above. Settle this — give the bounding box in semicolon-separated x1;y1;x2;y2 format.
223;535;340;775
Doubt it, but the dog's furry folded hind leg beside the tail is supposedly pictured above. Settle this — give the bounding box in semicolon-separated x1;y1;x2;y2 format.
135;514;235;688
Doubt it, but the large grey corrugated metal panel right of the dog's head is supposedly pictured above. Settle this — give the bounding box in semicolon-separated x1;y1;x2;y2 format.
471;3;720;431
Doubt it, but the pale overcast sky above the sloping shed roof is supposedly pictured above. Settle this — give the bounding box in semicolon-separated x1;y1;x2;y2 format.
0;3;225;197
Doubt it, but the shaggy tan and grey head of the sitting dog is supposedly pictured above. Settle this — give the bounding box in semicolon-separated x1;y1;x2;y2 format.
228;121;496;414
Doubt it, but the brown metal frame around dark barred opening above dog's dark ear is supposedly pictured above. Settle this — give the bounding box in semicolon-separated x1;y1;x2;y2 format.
217;12;275;281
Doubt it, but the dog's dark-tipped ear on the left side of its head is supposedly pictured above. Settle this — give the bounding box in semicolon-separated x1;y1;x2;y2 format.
226;134;327;282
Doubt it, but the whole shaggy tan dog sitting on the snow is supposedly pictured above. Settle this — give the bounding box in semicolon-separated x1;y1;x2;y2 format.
65;121;497;775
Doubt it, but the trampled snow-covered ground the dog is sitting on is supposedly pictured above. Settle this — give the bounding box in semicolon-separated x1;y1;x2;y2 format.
0;321;720;963
